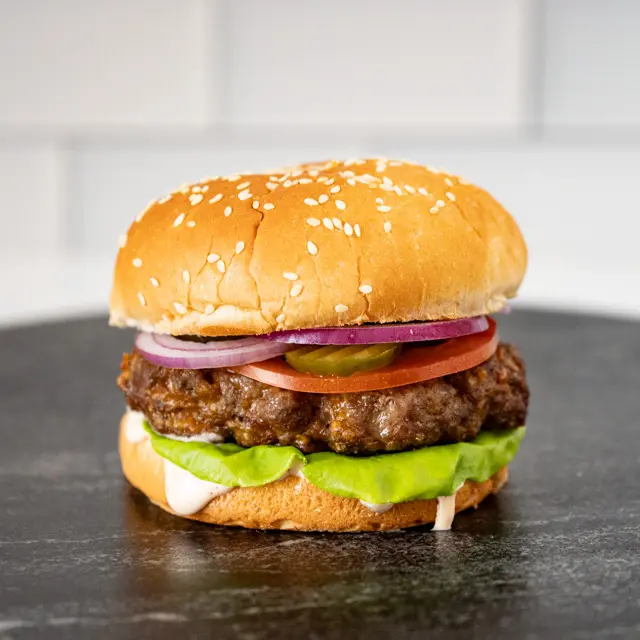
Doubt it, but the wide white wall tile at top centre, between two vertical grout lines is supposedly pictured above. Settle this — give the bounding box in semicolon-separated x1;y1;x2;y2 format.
227;0;530;128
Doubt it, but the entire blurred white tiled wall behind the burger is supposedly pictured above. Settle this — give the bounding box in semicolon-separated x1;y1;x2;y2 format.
0;0;640;323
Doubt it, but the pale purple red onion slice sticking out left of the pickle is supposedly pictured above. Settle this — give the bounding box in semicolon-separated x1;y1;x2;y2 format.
135;332;291;369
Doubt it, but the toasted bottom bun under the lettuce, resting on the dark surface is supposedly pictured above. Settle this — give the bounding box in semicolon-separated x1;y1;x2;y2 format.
120;422;508;531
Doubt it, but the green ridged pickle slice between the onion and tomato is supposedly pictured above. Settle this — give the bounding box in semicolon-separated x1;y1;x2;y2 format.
284;343;402;377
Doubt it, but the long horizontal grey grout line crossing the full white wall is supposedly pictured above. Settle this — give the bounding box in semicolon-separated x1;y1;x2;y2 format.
0;122;640;150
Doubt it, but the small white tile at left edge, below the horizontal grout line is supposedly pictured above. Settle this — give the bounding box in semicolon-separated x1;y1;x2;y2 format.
0;145;64;252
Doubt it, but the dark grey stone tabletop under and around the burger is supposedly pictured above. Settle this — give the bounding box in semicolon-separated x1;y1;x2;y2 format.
0;312;640;640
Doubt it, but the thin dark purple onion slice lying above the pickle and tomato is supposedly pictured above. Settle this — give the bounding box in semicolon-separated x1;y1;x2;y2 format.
260;316;489;345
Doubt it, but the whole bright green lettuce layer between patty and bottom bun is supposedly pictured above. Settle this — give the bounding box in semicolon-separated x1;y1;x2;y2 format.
145;424;525;504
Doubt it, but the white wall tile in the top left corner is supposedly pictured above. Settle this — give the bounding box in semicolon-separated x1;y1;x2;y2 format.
0;0;216;129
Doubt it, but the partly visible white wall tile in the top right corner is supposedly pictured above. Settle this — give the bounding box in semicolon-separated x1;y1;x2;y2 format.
543;0;640;127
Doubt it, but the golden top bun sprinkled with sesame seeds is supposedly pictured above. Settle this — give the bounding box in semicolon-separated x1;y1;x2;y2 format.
111;159;527;336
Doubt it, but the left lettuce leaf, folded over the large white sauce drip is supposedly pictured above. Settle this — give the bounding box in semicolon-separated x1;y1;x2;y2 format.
145;423;305;487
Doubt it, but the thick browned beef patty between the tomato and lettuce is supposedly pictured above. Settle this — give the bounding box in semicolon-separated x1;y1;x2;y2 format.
118;343;529;454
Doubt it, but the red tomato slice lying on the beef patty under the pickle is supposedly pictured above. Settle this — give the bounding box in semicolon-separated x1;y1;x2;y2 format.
230;318;498;393
